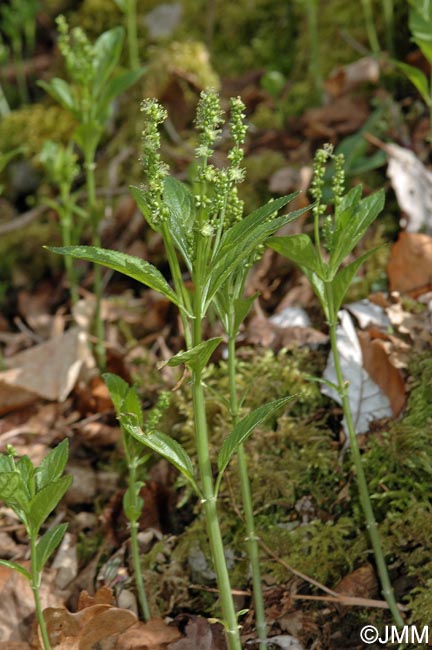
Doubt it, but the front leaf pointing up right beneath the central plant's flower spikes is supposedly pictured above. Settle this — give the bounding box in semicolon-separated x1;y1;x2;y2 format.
205;205;306;309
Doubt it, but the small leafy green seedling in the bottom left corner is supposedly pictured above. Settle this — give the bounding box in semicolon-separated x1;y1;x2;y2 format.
0;439;72;650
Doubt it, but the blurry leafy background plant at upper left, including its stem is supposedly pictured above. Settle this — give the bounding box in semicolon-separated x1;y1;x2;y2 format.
39;16;143;369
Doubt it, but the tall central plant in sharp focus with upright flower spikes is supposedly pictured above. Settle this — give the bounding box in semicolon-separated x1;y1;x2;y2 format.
46;91;302;650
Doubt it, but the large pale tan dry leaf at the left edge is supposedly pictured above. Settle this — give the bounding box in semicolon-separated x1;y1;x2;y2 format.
0;327;91;413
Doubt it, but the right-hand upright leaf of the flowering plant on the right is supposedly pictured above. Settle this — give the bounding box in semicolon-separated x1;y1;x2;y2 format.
328;190;384;280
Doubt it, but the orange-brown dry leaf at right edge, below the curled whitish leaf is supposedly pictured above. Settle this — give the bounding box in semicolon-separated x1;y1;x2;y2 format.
387;232;432;295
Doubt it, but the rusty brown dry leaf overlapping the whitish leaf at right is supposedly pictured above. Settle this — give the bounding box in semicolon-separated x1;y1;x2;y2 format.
357;332;405;416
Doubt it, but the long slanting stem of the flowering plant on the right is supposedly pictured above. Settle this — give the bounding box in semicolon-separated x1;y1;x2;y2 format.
325;283;404;627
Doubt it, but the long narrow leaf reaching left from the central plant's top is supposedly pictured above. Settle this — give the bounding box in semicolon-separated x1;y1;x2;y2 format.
47;246;186;308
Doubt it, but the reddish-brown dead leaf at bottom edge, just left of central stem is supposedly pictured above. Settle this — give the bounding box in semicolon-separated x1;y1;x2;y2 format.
116;618;181;650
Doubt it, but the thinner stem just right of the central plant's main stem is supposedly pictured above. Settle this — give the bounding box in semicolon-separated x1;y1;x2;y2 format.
228;333;267;650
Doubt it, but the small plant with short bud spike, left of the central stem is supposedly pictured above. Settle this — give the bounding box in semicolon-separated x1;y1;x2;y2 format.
103;373;169;621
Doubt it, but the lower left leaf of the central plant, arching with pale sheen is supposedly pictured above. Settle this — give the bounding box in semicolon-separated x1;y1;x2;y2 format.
122;414;199;493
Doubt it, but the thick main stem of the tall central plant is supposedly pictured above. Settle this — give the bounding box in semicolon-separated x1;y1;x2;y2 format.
192;260;241;650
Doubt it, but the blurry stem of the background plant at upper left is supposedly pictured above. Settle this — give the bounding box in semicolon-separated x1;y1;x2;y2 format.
84;144;106;372
